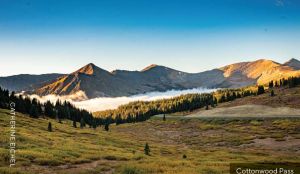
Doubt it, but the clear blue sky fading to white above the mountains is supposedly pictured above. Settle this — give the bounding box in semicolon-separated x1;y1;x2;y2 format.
0;0;300;76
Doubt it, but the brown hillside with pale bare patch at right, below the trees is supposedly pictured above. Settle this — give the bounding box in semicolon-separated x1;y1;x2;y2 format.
184;86;300;117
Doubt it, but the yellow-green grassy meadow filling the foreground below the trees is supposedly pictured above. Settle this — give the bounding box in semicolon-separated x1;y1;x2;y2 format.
0;110;300;174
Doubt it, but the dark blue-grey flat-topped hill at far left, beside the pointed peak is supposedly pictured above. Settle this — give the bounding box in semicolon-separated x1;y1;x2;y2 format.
0;74;63;91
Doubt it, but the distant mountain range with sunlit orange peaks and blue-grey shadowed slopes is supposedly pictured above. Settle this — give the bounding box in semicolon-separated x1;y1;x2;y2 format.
0;59;300;98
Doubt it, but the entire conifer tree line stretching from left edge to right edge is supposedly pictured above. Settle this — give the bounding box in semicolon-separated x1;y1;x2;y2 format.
0;77;300;130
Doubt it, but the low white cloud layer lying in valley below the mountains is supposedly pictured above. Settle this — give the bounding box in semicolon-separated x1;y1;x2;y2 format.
24;88;216;112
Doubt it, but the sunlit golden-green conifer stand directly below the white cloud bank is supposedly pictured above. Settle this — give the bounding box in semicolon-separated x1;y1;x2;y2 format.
94;94;213;124
